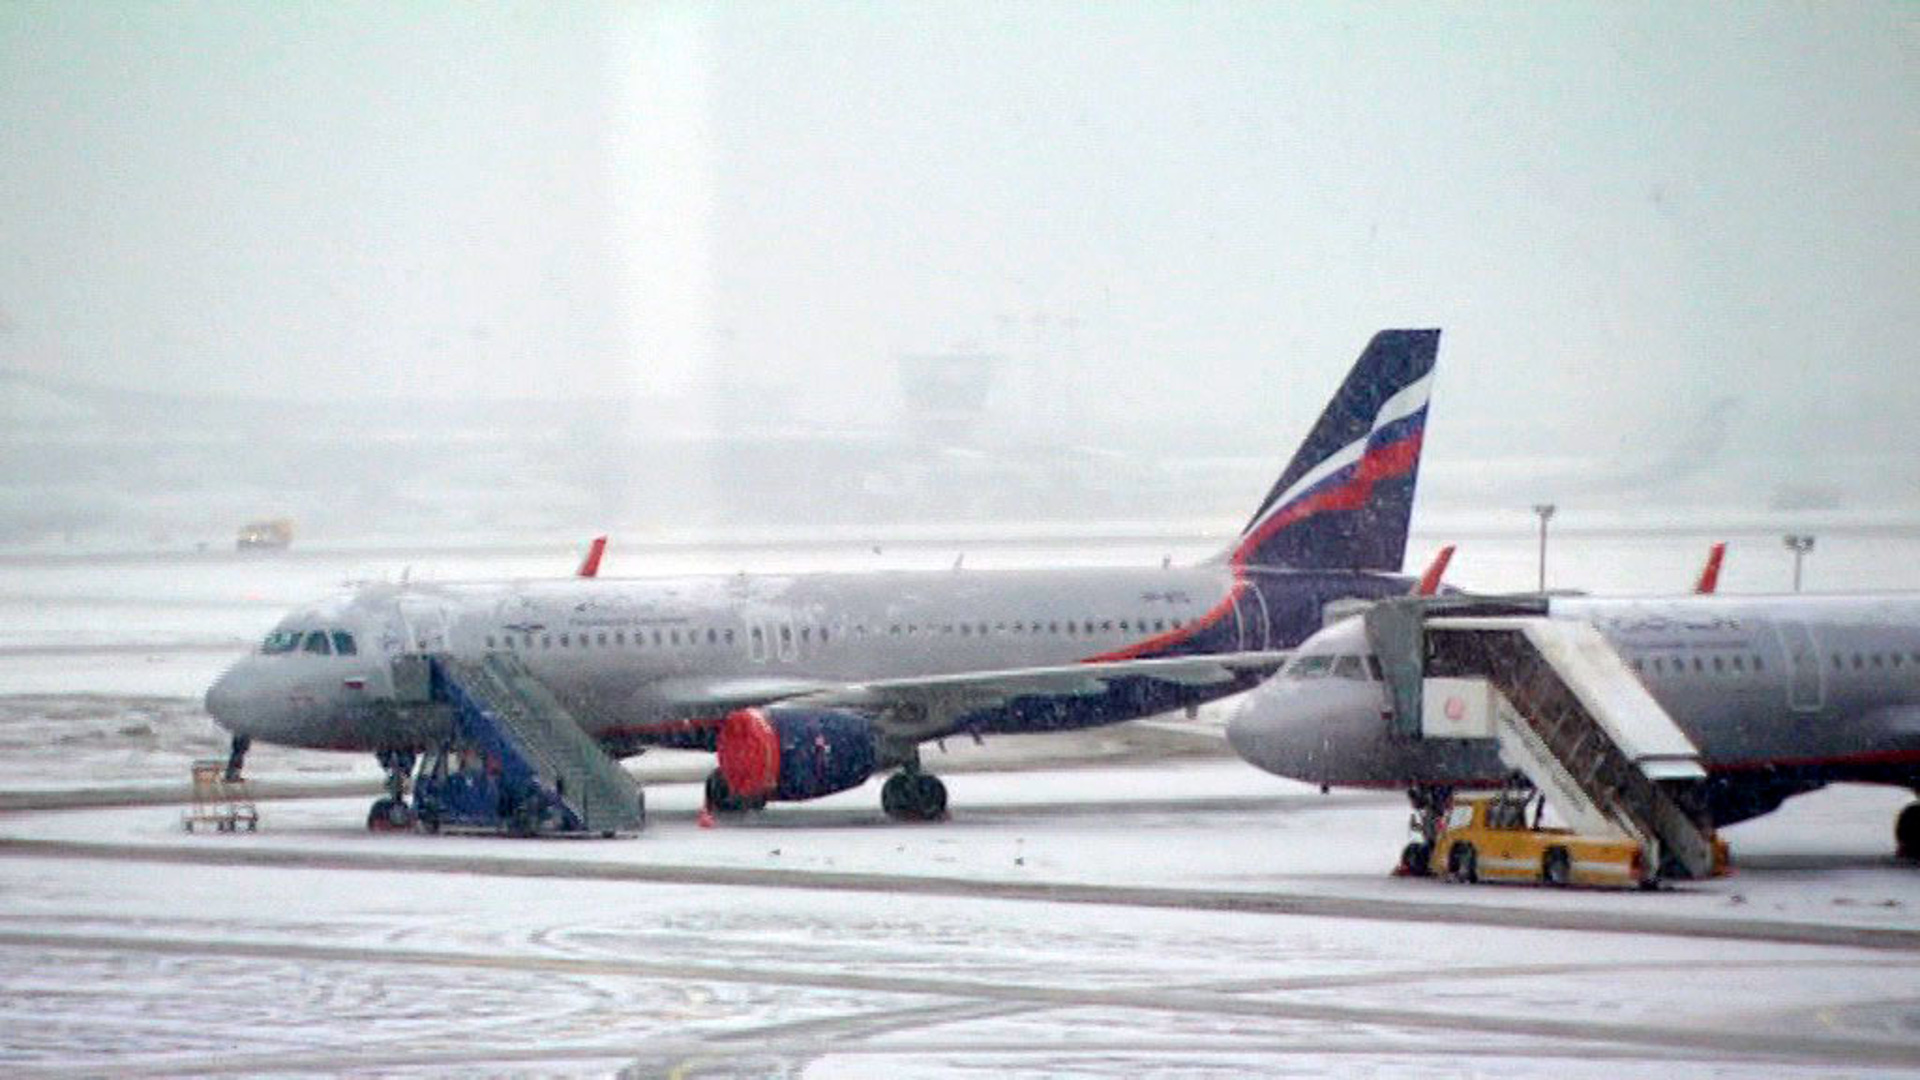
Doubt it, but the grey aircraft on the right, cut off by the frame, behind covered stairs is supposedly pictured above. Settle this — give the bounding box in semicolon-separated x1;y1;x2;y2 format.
1227;594;1920;855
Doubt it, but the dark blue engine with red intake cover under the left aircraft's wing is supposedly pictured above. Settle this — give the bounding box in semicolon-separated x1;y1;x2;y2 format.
716;705;874;803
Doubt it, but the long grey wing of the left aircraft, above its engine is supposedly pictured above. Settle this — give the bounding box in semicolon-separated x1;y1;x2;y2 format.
783;651;1286;742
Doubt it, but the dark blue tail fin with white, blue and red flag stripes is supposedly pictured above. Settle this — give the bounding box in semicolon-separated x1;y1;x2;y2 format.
1231;331;1440;571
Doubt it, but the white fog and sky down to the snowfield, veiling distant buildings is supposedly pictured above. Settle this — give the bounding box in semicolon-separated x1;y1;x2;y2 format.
0;2;1920;546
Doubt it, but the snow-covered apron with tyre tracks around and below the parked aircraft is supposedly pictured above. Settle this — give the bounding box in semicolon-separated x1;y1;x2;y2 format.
0;534;1920;1080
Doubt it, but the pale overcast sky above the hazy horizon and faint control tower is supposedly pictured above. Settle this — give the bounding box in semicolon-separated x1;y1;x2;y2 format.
0;0;1920;472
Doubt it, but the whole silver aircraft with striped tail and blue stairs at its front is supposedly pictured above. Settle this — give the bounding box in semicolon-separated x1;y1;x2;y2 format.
207;322;1440;819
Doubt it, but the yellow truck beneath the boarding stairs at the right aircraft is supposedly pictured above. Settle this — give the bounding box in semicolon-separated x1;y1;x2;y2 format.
1428;792;1658;888
